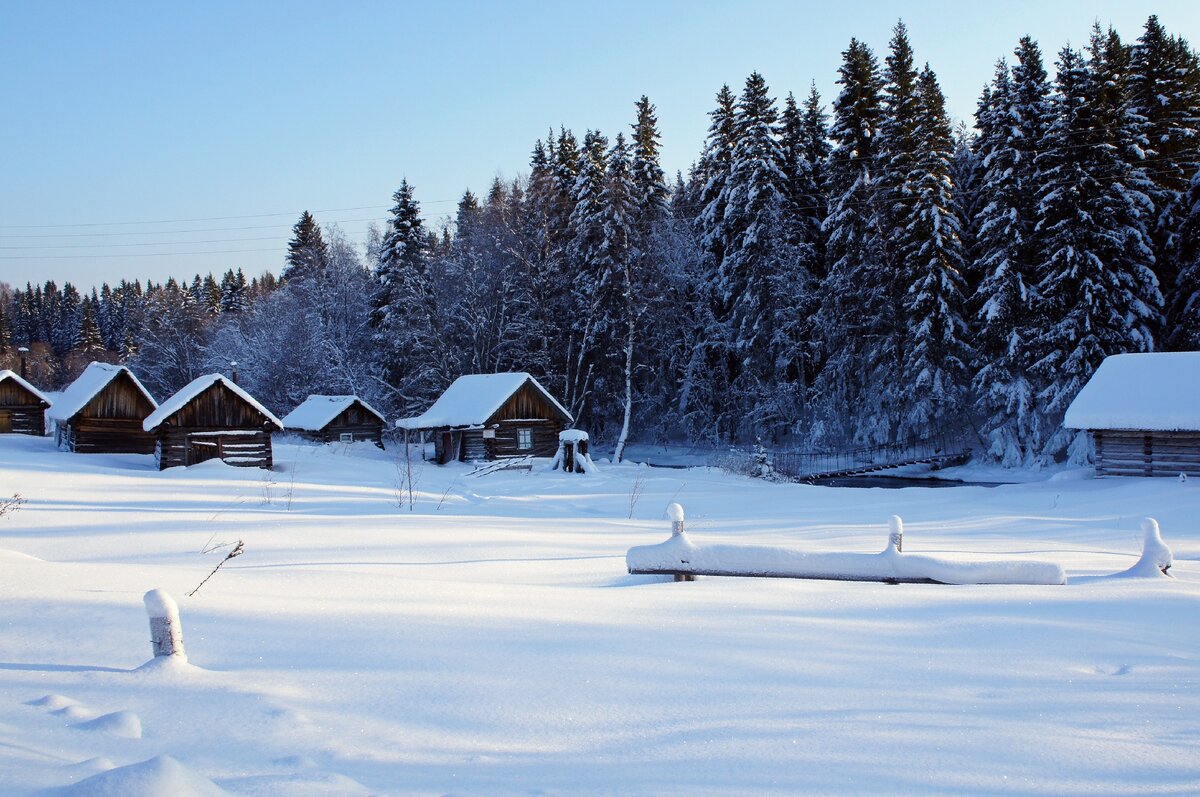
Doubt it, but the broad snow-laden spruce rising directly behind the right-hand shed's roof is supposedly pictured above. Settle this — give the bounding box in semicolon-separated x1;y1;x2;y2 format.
1033;40;1162;462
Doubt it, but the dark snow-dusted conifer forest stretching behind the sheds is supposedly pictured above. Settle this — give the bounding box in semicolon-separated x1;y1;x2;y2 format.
0;17;1200;466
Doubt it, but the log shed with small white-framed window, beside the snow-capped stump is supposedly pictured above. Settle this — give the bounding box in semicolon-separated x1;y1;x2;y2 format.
396;372;574;465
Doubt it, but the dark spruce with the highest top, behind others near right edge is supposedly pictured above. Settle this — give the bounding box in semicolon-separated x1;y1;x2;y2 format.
1128;16;1200;306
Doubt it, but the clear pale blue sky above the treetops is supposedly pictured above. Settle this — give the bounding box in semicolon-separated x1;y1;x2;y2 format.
0;0;1200;287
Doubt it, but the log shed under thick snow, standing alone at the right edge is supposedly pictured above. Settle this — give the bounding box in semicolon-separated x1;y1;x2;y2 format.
1063;352;1200;477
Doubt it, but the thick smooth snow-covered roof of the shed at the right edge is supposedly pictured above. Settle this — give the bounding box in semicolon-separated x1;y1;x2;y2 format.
1063;352;1200;432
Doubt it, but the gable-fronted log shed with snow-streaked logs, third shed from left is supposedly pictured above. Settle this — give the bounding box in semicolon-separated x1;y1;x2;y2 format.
142;373;283;471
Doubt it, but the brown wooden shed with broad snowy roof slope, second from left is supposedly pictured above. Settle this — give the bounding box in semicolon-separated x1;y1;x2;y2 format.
47;362;158;454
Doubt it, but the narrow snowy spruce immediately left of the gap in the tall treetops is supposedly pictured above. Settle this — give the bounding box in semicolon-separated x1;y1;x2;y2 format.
899;65;971;438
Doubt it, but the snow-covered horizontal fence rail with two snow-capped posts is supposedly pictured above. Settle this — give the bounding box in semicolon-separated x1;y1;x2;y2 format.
625;504;1067;585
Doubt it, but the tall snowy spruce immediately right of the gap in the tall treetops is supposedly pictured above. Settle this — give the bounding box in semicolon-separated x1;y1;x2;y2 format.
972;36;1052;466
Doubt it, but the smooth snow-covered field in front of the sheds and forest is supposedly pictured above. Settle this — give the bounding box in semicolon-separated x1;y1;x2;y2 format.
0;435;1200;797
